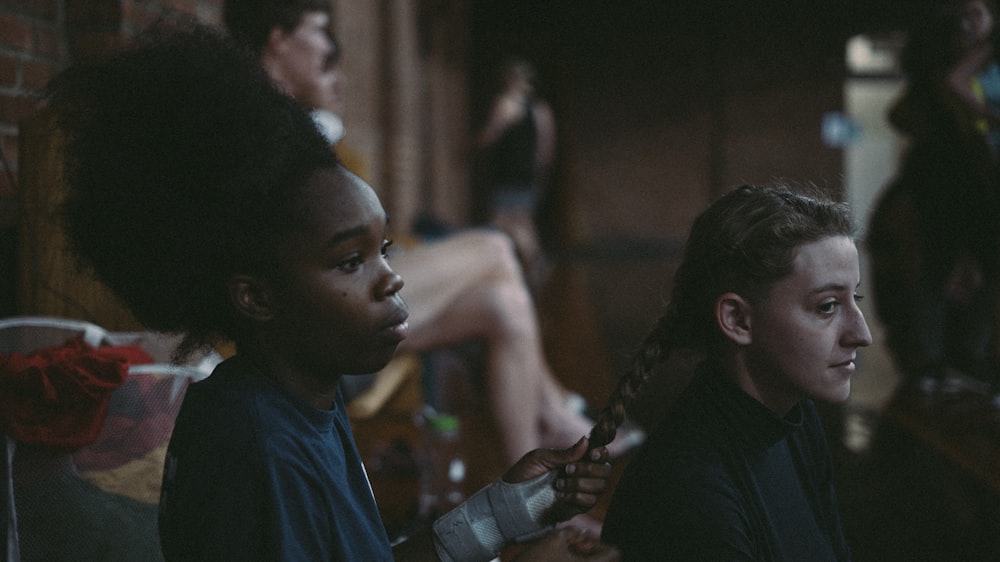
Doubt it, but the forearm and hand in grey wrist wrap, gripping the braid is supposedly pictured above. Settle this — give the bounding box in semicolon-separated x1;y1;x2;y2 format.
393;438;611;562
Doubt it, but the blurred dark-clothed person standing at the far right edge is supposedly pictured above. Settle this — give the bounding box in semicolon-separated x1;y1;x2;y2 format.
866;0;1000;393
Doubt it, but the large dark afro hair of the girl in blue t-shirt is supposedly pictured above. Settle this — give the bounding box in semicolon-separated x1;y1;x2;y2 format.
47;27;336;350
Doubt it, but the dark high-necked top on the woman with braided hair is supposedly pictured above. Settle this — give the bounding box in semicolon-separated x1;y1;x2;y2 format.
602;366;850;562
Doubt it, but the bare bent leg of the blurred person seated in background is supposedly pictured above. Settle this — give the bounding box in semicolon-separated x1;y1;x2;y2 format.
392;231;590;462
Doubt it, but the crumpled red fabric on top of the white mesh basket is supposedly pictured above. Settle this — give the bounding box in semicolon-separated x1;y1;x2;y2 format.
0;337;153;452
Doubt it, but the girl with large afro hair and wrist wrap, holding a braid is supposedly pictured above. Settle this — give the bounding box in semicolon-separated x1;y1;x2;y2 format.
48;29;616;561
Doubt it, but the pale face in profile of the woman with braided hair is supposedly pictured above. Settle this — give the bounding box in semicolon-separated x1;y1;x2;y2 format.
741;236;871;415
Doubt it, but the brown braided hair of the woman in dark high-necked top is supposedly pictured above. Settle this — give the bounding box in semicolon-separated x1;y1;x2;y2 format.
590;185;854;447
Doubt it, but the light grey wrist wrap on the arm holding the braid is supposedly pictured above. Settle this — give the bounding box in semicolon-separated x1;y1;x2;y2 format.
434;470;558;562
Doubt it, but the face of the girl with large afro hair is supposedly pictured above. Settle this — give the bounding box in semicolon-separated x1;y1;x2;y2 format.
269;168;408;376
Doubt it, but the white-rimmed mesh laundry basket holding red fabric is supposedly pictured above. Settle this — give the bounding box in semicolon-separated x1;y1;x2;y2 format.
0;317;221;562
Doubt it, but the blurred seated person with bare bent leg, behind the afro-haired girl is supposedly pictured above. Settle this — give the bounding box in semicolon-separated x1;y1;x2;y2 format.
224;0;642;462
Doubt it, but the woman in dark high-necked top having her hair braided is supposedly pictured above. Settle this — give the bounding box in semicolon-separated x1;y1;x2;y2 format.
591;186;871;560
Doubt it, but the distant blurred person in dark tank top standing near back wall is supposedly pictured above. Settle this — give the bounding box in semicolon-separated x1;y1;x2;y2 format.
476;59;556;286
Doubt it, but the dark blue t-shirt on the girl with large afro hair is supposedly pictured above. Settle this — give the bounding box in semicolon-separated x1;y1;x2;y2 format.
160;357;392;561
